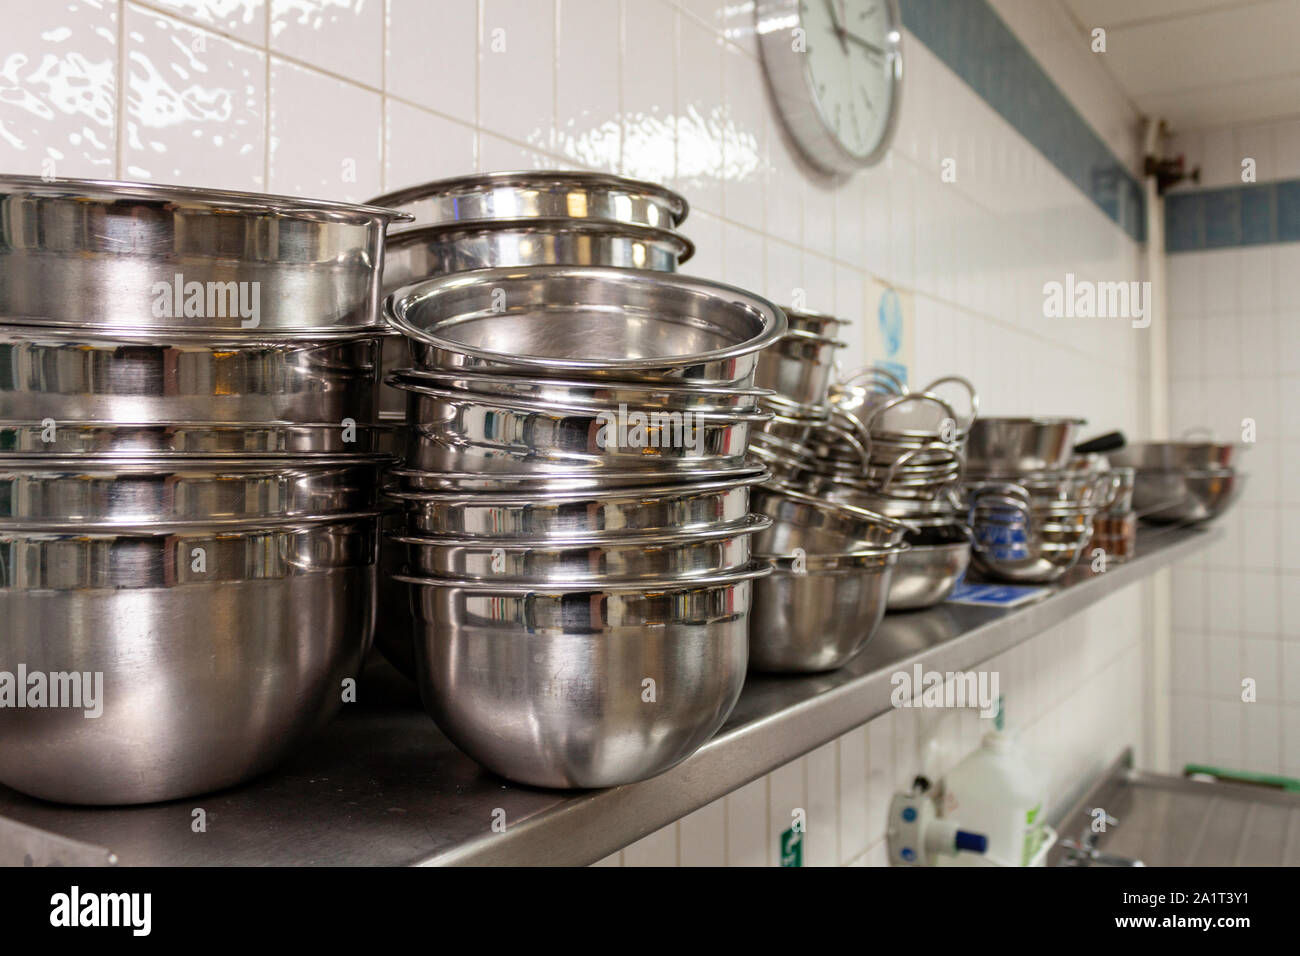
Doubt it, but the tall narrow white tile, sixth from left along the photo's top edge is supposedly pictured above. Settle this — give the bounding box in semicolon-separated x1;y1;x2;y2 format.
555;0;618;171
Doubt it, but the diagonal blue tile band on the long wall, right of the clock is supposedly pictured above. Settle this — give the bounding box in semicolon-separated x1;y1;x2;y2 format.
900;0;1144;242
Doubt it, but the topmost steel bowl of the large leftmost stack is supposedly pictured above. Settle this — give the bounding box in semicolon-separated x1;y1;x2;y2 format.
0;176;408;336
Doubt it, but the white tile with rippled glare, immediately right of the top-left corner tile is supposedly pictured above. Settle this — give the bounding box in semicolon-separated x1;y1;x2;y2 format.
122;4;267;190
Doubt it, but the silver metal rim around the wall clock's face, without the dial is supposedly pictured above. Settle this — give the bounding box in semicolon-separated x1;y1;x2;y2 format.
754;0;902;174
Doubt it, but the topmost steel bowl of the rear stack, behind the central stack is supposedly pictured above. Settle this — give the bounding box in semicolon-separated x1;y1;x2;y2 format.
371;169;689;229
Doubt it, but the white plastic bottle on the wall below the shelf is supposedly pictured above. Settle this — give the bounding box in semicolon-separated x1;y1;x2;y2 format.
940;701;1044;866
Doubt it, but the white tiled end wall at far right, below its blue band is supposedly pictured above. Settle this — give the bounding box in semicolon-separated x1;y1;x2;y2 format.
1169;235;1300;777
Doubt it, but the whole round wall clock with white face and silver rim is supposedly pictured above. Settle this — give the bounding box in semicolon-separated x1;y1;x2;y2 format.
755;0;902;172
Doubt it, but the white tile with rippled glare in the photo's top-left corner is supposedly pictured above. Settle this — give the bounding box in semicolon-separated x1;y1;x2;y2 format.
0;0;118;179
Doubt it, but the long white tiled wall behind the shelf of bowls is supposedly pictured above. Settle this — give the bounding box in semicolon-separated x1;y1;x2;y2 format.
0;0;1145;864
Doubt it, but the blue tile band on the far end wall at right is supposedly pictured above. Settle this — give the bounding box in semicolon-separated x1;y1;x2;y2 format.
1165;179;1300;252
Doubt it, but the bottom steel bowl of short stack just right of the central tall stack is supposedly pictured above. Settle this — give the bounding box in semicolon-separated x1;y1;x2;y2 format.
749;545;907;674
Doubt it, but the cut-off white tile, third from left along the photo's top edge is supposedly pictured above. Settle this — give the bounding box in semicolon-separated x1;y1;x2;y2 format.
270;0;384;88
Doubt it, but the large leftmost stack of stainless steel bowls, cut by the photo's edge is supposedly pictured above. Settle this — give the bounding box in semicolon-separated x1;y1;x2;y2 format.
0;177;405;804
